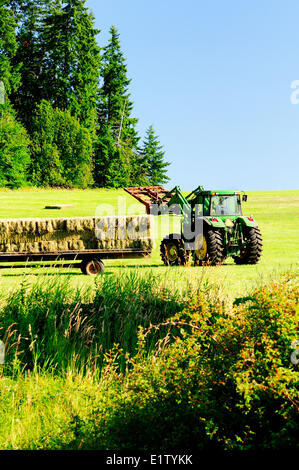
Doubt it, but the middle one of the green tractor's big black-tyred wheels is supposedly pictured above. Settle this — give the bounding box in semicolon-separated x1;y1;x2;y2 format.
194;229;225;266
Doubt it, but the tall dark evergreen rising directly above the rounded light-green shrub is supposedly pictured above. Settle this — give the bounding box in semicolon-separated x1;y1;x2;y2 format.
41;0;100;131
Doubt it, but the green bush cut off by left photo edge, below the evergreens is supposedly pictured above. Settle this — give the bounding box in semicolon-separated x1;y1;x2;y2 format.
0;105;30;188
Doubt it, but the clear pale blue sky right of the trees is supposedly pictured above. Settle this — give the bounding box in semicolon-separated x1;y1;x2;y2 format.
87;0;299;190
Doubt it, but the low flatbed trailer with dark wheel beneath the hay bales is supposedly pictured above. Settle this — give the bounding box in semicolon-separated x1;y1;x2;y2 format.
0;248;151;275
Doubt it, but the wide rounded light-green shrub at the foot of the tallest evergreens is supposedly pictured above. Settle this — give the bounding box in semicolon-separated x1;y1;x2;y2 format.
32;100;93;188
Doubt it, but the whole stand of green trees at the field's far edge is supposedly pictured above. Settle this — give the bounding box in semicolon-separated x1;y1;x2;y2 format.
0;0;169;188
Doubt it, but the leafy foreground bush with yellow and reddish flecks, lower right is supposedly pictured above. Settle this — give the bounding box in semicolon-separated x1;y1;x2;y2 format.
78;278;299;450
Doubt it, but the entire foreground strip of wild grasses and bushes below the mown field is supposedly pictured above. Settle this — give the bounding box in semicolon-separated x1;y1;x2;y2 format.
0;272;299;450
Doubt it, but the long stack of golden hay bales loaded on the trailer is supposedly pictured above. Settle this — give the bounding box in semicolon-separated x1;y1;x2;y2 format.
0;215;153;253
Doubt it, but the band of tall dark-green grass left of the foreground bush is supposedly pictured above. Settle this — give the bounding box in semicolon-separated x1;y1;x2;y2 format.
0;270;210;373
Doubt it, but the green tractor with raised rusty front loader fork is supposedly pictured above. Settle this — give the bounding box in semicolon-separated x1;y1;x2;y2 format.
125;186;262;266
